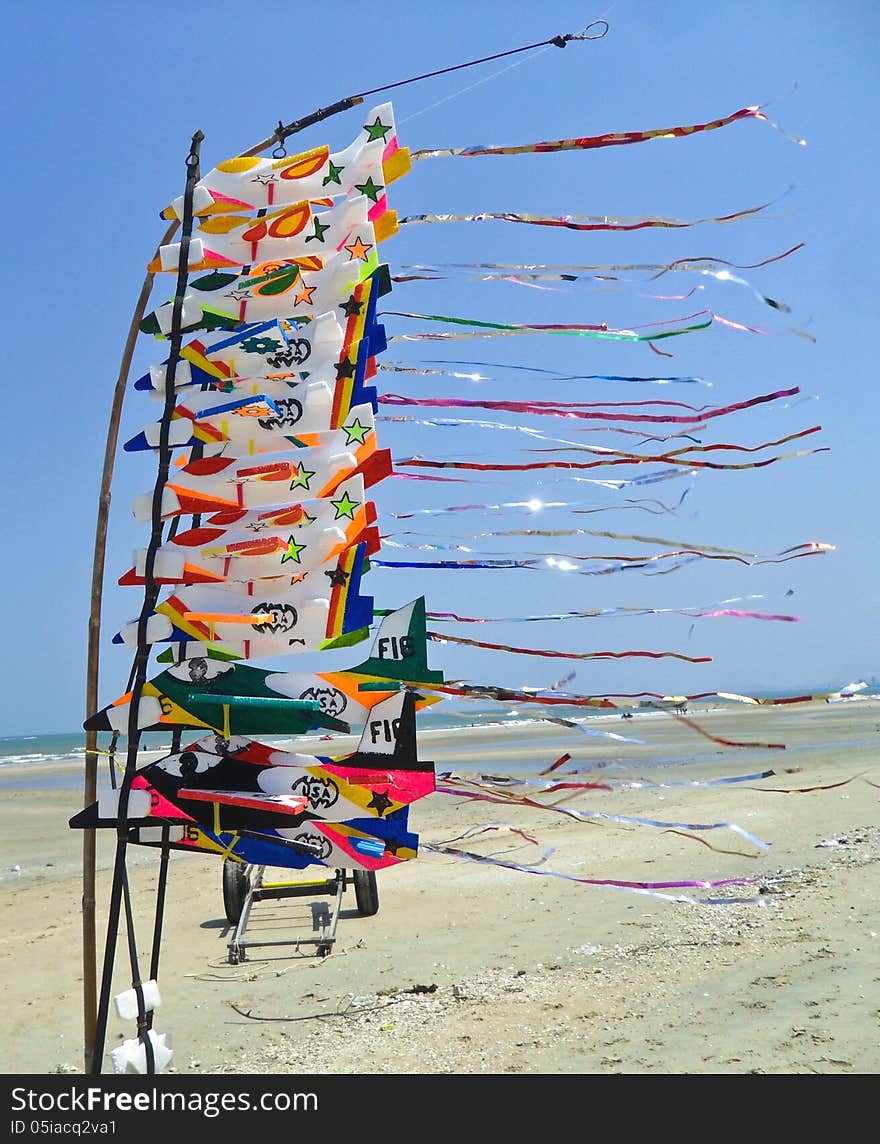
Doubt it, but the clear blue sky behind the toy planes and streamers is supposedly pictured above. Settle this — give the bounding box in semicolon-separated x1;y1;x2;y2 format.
0;0;880;734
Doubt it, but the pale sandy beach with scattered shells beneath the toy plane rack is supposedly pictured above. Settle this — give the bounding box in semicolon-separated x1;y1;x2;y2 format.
0;700;880;1077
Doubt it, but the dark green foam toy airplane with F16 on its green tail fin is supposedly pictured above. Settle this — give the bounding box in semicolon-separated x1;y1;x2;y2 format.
82;596;443;738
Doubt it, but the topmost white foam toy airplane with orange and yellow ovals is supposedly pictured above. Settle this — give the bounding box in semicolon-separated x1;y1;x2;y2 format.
161;103;411;220
